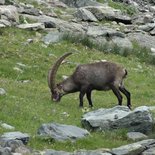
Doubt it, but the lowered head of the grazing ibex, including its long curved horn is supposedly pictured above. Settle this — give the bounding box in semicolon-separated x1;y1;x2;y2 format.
48;52;72;102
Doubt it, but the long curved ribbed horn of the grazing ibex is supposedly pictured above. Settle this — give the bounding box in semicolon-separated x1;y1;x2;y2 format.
48;52;72;91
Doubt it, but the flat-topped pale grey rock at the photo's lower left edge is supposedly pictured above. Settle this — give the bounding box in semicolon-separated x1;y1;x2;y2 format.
0;131;30;145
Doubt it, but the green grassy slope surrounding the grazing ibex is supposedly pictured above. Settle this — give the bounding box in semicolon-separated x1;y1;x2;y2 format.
0;28;155;151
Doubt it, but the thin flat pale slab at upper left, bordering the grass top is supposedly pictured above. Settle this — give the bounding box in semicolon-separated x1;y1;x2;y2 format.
17;23;45;30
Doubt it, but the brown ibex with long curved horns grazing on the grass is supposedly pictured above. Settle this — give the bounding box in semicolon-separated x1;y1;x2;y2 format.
48;52;131;108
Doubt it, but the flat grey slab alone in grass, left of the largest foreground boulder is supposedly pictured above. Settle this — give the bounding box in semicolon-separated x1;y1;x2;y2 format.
38;123;89;141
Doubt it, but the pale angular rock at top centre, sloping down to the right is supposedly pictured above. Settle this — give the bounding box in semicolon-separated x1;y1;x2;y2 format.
75;8;98;22
